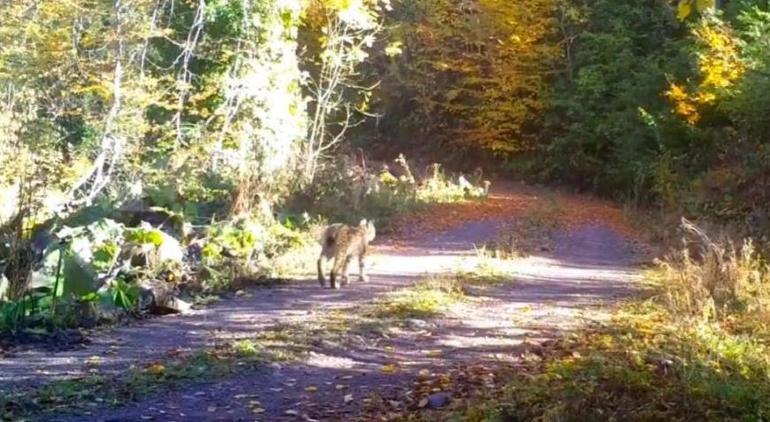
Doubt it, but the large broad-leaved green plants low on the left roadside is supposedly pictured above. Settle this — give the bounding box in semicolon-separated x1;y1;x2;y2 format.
0;219;188;331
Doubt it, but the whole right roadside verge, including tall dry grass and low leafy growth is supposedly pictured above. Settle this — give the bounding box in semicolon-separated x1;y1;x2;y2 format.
436;221;770;421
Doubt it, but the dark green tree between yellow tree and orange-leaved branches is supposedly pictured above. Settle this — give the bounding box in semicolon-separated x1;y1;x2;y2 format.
542;1;689;199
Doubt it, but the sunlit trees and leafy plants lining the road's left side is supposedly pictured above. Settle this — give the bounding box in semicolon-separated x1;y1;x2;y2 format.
0;0;489;340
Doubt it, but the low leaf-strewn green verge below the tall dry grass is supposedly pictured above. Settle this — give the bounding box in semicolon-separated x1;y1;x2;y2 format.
452;303;770;421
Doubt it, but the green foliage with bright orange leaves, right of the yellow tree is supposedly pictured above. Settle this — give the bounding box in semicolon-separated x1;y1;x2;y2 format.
531;1;768;231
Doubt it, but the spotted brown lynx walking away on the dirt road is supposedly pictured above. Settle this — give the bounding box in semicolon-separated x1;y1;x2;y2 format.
318;219;375;289
